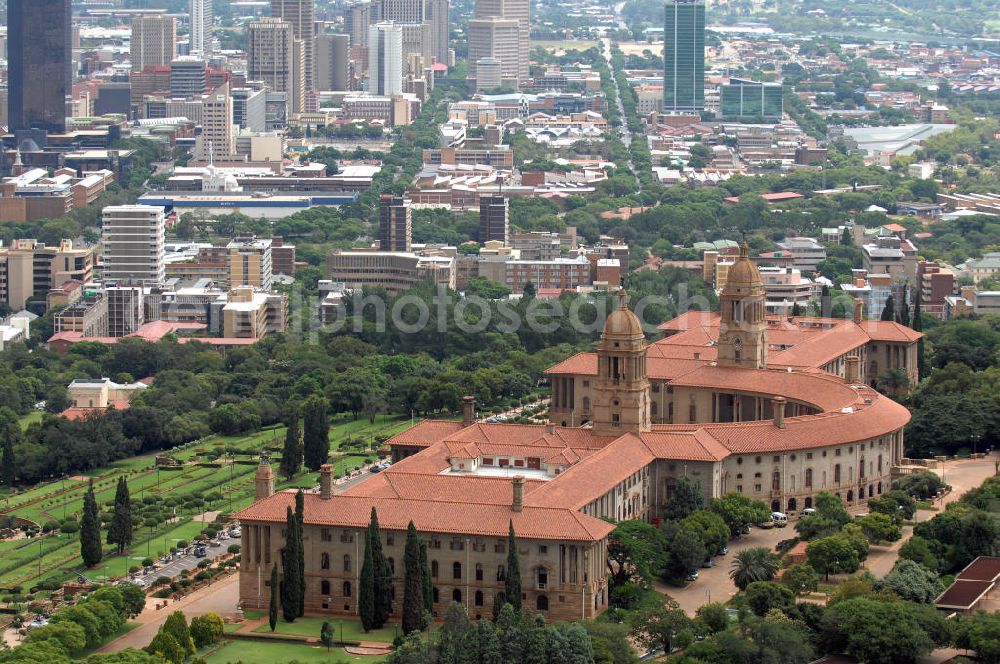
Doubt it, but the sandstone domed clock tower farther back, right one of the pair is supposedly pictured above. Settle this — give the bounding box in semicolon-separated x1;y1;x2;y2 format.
718;242;767;369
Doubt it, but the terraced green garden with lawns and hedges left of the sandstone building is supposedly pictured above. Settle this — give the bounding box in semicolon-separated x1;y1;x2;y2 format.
0;416;410;589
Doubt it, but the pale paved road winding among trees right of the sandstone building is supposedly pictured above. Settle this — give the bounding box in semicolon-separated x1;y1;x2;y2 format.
656;457;996;615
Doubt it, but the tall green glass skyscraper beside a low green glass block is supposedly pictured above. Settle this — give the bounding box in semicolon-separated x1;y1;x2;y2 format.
663;0;705;112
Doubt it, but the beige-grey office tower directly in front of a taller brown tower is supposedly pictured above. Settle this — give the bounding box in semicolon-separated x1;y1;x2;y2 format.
247;16;306;113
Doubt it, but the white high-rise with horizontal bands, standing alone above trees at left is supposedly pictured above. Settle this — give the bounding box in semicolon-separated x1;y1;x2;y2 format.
101;205;166;286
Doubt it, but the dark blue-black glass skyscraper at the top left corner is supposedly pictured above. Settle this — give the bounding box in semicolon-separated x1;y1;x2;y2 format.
7;0;73;133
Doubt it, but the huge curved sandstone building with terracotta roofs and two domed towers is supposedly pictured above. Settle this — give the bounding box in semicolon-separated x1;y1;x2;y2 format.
236;245;920;620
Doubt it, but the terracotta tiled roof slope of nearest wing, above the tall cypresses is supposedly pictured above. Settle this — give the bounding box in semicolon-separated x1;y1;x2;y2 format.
236;491;614;542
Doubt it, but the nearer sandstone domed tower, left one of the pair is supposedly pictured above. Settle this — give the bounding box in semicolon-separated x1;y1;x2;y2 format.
592;288;650;436
